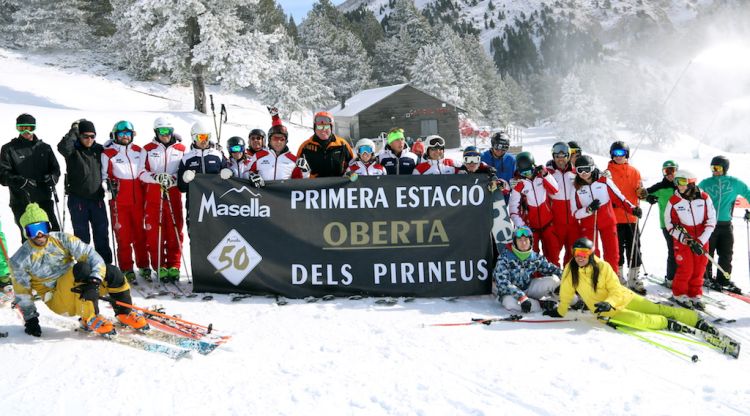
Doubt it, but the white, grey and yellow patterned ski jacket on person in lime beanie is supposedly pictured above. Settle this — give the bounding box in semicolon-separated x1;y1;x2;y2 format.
10;231;106;291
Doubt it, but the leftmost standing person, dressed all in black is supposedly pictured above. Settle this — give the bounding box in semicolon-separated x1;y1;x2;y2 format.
0;113;60;243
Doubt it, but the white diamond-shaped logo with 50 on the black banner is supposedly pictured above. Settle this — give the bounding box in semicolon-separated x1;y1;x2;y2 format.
206;229;263;286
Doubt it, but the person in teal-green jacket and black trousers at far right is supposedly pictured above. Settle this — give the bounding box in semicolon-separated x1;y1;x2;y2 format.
698;156;750;293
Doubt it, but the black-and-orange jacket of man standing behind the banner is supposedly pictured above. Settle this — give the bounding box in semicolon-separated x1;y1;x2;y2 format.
296;134;354;179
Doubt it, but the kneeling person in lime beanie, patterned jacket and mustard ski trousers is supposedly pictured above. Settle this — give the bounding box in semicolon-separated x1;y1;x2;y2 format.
10;204;148;337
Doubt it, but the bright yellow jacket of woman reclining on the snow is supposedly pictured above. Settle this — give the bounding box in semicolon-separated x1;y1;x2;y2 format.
557;254;635;316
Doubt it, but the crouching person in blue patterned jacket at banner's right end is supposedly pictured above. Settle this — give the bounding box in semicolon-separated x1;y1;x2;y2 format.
492;227;562;313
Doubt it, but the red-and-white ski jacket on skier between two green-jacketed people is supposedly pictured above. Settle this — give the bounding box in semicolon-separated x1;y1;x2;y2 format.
664;189;716;245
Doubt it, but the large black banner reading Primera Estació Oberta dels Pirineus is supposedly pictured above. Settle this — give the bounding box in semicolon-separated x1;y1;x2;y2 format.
189;175;493;298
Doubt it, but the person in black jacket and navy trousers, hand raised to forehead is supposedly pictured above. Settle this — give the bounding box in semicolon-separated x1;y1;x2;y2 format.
57;119;112;264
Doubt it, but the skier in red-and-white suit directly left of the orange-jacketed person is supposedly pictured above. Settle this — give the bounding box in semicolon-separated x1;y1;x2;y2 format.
570;155;643;273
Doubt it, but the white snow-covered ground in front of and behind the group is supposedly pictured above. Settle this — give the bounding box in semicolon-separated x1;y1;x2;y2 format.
0;50;750;415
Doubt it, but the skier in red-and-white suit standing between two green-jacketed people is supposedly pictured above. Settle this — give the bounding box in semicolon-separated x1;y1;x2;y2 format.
664;170;716;310
